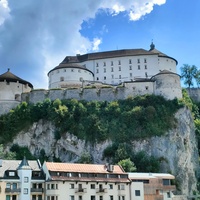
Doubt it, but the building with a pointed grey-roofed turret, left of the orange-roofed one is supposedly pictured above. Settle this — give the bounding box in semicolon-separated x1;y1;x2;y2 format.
0;157;44;200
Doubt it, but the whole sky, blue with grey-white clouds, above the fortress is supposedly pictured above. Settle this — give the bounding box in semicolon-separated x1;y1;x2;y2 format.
0;0;200;89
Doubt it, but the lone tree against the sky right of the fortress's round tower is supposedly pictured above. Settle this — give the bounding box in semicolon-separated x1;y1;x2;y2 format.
181;64;199;88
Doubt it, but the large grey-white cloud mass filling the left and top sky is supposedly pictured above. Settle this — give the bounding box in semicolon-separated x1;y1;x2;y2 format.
0;0;165;88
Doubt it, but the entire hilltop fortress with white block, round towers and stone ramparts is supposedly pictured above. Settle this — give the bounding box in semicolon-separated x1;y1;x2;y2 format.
0;43;182;114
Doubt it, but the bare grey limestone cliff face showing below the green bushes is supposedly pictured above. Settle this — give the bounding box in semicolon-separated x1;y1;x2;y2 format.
8;108;198;195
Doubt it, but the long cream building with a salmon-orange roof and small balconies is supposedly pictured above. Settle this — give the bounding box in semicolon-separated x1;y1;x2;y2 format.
43;162;131;200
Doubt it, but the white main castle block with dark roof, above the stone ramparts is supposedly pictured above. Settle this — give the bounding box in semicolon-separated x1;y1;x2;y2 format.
48;43;178;89
